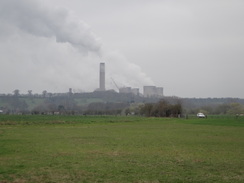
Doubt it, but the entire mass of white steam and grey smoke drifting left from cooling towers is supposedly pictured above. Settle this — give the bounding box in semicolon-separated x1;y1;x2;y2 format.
0;0;152;93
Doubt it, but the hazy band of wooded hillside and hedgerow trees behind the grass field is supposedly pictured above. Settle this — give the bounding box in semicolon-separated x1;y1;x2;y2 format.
0;90;244;117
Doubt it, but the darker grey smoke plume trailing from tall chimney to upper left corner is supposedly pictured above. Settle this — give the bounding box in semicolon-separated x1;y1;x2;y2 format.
0;0;101;53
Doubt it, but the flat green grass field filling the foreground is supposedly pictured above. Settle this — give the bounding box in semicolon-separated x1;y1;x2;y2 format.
0;115;244;183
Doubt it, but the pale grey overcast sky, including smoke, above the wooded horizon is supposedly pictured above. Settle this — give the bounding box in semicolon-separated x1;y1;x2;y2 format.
0;0;244;98
